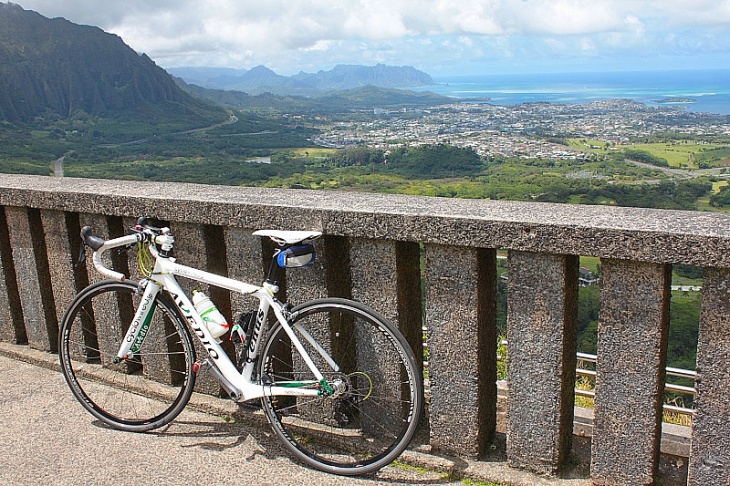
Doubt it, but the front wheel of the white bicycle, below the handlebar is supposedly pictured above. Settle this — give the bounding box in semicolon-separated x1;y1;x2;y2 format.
58;280;195;432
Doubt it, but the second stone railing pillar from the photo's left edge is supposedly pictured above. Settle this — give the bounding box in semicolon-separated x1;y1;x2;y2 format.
5;206;58;352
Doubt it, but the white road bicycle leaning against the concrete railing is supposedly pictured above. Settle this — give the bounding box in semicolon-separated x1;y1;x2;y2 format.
59;217;423;476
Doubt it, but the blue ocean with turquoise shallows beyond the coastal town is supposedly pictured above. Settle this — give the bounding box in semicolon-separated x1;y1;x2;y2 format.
410;69;730;115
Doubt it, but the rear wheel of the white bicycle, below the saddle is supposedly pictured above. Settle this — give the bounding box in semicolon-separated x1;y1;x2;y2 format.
258;298;423;476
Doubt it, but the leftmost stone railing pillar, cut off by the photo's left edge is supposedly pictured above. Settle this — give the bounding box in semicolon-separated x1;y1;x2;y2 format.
0;206;28;344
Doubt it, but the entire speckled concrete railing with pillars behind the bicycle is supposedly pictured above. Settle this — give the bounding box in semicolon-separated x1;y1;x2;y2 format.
0;174;730;485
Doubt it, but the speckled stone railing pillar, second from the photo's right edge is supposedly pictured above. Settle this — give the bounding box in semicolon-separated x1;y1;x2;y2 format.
591;260;671;485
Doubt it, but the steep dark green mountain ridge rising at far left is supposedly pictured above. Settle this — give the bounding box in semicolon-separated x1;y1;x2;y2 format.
0;3;226;125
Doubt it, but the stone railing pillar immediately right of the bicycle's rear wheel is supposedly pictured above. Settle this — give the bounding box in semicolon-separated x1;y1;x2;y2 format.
425;245;497;457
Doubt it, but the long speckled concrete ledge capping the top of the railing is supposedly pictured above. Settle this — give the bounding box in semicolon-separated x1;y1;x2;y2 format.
0;174;730;267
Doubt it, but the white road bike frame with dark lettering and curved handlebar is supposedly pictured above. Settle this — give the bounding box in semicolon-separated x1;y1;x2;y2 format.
93;234;339;402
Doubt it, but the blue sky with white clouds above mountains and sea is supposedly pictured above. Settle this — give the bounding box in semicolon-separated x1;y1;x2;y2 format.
14;0;730;77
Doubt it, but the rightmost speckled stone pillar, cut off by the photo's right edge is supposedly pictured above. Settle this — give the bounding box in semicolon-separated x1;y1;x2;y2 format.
688;268;730;486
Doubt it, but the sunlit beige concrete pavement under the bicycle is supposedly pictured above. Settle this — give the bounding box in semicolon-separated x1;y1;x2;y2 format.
0;343;444;486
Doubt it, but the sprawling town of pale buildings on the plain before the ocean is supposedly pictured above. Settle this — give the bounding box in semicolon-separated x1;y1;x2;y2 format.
314;100;730;159
